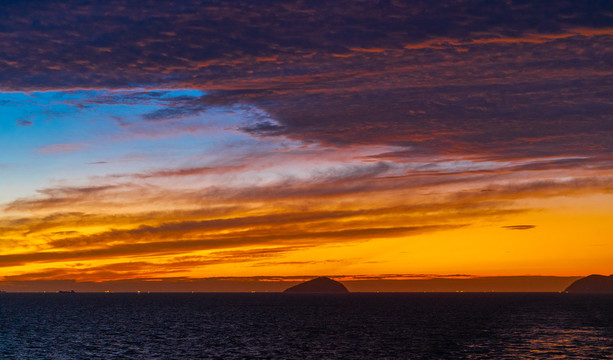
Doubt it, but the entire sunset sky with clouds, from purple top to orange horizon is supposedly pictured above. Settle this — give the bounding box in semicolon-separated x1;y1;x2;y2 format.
0;0;613;291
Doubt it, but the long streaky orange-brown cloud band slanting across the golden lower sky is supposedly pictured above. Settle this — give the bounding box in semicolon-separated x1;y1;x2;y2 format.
0;164;612;267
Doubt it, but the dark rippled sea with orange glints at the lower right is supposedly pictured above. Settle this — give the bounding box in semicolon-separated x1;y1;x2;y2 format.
0;293;613;359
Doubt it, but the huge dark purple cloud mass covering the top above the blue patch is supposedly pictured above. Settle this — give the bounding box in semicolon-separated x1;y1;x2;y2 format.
0;0;613;158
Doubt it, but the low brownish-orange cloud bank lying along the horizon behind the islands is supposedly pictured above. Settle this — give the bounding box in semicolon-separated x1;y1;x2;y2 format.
0;276;580;293
